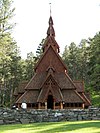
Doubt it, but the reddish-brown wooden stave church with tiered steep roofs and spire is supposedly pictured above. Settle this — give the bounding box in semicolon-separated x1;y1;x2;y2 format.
14;15;91;109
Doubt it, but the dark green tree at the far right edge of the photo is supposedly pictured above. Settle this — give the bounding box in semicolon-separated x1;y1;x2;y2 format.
88;32;100;92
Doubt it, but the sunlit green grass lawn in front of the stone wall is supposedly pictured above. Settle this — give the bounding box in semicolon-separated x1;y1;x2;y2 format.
0;121;100;133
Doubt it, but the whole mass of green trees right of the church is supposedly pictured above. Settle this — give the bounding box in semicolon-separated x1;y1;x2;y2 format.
62;32;100;104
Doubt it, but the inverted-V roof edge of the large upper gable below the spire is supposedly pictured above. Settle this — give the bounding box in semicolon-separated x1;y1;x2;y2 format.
35;45;67;71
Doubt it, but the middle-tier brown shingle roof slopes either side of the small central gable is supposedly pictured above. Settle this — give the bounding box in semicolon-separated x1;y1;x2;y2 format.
25;69;76;90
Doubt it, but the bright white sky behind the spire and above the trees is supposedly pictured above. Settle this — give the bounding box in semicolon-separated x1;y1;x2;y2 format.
13;0;100;58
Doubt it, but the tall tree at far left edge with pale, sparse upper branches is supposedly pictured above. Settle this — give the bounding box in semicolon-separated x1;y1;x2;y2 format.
0;0;19;105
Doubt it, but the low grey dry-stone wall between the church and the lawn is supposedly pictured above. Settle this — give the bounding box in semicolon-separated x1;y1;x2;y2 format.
0;108;100;125
